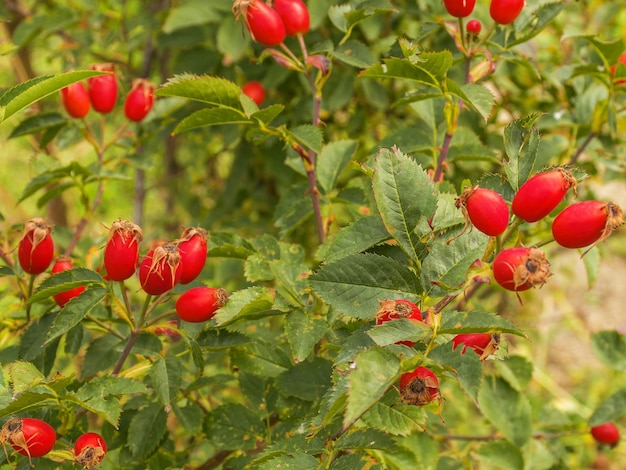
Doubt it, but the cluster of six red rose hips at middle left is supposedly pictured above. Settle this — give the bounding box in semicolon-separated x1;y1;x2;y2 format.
18;218;228;322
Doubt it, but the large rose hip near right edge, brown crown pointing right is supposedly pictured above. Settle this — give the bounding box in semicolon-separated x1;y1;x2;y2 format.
552;201;624;248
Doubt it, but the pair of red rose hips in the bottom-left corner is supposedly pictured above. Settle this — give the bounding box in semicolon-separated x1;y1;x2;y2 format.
0;418;107;469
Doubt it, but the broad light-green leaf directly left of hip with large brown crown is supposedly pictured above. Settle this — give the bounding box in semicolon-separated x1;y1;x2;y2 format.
421;230;489;297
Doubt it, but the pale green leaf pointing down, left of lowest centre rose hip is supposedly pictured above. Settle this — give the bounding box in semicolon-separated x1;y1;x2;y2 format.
343;347;400;429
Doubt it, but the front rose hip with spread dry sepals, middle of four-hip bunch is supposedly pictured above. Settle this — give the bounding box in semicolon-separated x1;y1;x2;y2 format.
139;242;183;295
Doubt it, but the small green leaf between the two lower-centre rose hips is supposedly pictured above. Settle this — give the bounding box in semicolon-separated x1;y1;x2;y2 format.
429;342;483;401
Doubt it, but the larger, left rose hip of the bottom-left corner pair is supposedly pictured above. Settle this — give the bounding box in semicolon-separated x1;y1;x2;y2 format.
0;418;57;458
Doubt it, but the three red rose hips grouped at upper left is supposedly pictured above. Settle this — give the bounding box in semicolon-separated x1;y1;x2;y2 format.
61;64;155;122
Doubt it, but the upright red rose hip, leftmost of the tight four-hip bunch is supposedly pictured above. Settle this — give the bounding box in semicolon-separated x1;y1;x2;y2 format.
104;219;143;281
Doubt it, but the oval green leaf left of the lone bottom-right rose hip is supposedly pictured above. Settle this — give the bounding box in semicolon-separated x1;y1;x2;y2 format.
478;376;532;447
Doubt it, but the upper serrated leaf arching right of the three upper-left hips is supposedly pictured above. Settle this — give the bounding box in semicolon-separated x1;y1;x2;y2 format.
156;74;241;110
